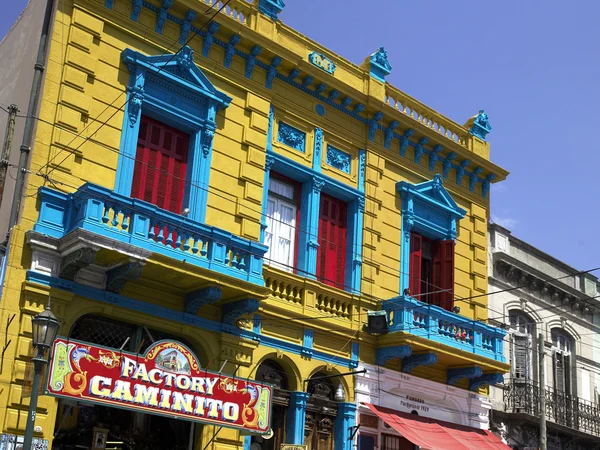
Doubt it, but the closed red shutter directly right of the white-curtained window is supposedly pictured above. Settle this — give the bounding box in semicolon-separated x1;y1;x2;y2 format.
317;194;347;289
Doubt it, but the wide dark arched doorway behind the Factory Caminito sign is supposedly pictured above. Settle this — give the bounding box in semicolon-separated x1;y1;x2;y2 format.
52;315;201;450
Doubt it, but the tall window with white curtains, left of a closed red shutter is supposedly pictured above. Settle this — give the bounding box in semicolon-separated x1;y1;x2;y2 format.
265;176;300;272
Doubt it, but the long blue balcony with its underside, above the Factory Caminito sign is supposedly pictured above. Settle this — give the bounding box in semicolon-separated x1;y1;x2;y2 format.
28;183;267;291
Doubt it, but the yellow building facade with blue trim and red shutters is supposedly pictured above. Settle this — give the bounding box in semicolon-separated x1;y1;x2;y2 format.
0;0;509;450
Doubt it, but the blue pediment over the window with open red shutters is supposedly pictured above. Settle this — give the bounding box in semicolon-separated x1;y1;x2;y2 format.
396;174;467;239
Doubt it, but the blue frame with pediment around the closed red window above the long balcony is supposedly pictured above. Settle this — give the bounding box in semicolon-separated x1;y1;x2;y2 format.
114;46;231;222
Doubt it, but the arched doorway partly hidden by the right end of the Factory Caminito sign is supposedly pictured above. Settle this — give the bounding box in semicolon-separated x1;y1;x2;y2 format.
250;359;290;450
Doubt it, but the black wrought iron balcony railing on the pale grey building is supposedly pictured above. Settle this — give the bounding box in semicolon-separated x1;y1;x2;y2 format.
504;379;600;436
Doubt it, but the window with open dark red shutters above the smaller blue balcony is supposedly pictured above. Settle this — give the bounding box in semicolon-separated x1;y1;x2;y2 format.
409;233;454;311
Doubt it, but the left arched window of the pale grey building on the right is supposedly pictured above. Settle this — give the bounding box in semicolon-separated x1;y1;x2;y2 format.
509;310;535;381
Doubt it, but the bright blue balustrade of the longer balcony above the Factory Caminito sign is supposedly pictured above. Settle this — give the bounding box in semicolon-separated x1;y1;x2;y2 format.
34;183;267;286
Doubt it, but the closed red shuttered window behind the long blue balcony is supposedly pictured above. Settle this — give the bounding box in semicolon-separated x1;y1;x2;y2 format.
131;116;189;214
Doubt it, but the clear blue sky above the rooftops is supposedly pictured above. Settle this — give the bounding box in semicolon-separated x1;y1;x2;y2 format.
0;0;600;275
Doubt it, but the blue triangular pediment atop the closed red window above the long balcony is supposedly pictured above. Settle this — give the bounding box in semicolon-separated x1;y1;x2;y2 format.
121;46;231;109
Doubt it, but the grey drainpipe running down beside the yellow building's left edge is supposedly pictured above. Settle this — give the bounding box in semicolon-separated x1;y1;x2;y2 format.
8;0;54;233
